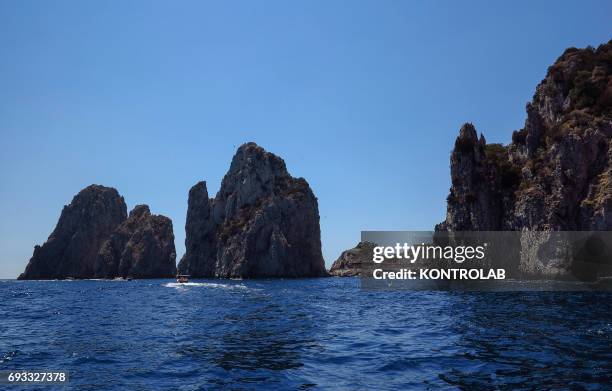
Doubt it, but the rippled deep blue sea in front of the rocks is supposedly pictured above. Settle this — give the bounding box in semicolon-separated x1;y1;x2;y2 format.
0;278;612;390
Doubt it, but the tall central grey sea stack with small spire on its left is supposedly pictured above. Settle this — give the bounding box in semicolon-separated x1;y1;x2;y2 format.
179;143;326;278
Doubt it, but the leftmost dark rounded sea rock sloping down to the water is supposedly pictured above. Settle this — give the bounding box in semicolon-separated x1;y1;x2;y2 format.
19;185;127;280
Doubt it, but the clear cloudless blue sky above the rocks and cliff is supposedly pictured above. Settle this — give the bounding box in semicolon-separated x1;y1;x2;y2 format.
0;0;612;278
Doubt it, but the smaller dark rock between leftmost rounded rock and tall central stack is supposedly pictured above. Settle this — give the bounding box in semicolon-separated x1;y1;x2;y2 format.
95;205;176;278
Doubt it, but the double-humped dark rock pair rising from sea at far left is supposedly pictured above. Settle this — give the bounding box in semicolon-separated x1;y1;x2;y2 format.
19;185;176;280
